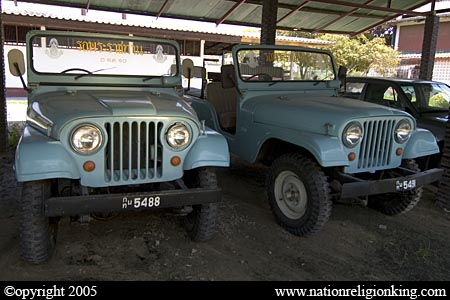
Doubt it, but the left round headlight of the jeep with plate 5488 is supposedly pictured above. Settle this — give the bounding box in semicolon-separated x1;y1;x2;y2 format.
71;125;102;154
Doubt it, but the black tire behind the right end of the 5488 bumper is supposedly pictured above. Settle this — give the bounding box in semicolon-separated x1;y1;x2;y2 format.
183;168;218;242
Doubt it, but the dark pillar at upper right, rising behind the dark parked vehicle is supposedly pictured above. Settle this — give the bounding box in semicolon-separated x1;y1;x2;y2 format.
419;12;439;80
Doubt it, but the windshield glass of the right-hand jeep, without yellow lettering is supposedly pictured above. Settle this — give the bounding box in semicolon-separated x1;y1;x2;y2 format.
237;49;335;81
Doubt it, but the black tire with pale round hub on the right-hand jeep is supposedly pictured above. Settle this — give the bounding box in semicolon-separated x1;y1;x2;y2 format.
267;153;332;236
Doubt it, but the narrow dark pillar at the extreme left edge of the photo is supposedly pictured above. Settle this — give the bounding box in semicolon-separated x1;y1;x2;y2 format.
0;1;9;153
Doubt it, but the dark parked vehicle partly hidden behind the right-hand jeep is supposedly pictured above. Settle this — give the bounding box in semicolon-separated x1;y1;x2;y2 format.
343;77;450;168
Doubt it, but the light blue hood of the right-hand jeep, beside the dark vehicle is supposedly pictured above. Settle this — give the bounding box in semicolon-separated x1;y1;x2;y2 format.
251;94;412;134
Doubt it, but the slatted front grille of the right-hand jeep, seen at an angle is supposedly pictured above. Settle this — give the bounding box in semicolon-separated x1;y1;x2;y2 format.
358;119;395;169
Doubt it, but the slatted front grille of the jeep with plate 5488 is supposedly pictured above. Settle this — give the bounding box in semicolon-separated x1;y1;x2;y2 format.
105;121;163;182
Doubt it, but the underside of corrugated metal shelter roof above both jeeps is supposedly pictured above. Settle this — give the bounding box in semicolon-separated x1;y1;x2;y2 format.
7;0;432;34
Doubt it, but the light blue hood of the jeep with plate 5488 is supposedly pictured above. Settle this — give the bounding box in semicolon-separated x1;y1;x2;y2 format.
29;91;197;132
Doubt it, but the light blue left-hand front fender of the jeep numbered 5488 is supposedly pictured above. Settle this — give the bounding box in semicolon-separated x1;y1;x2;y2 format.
15;126;80;182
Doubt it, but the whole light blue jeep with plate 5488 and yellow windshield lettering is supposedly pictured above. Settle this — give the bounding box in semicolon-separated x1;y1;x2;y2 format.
8;31;229;263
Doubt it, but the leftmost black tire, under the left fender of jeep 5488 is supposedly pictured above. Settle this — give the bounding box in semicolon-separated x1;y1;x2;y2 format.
19;180;58;264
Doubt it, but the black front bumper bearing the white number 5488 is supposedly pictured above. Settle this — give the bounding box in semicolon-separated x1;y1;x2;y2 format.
44;188;222;217
